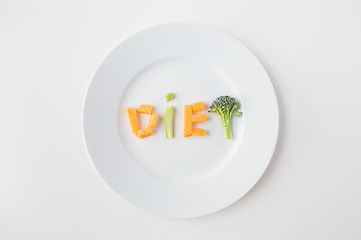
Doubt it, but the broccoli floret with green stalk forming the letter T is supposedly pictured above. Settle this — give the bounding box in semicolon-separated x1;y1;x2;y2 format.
208;96;242;139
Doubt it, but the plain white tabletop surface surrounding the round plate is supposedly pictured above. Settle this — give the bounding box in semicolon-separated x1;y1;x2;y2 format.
0;0;361;240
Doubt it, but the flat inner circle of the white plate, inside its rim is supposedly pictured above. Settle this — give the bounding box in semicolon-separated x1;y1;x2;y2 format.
118;58;243;183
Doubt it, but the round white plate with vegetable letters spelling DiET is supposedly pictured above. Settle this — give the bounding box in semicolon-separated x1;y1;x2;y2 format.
83;23;278;218
